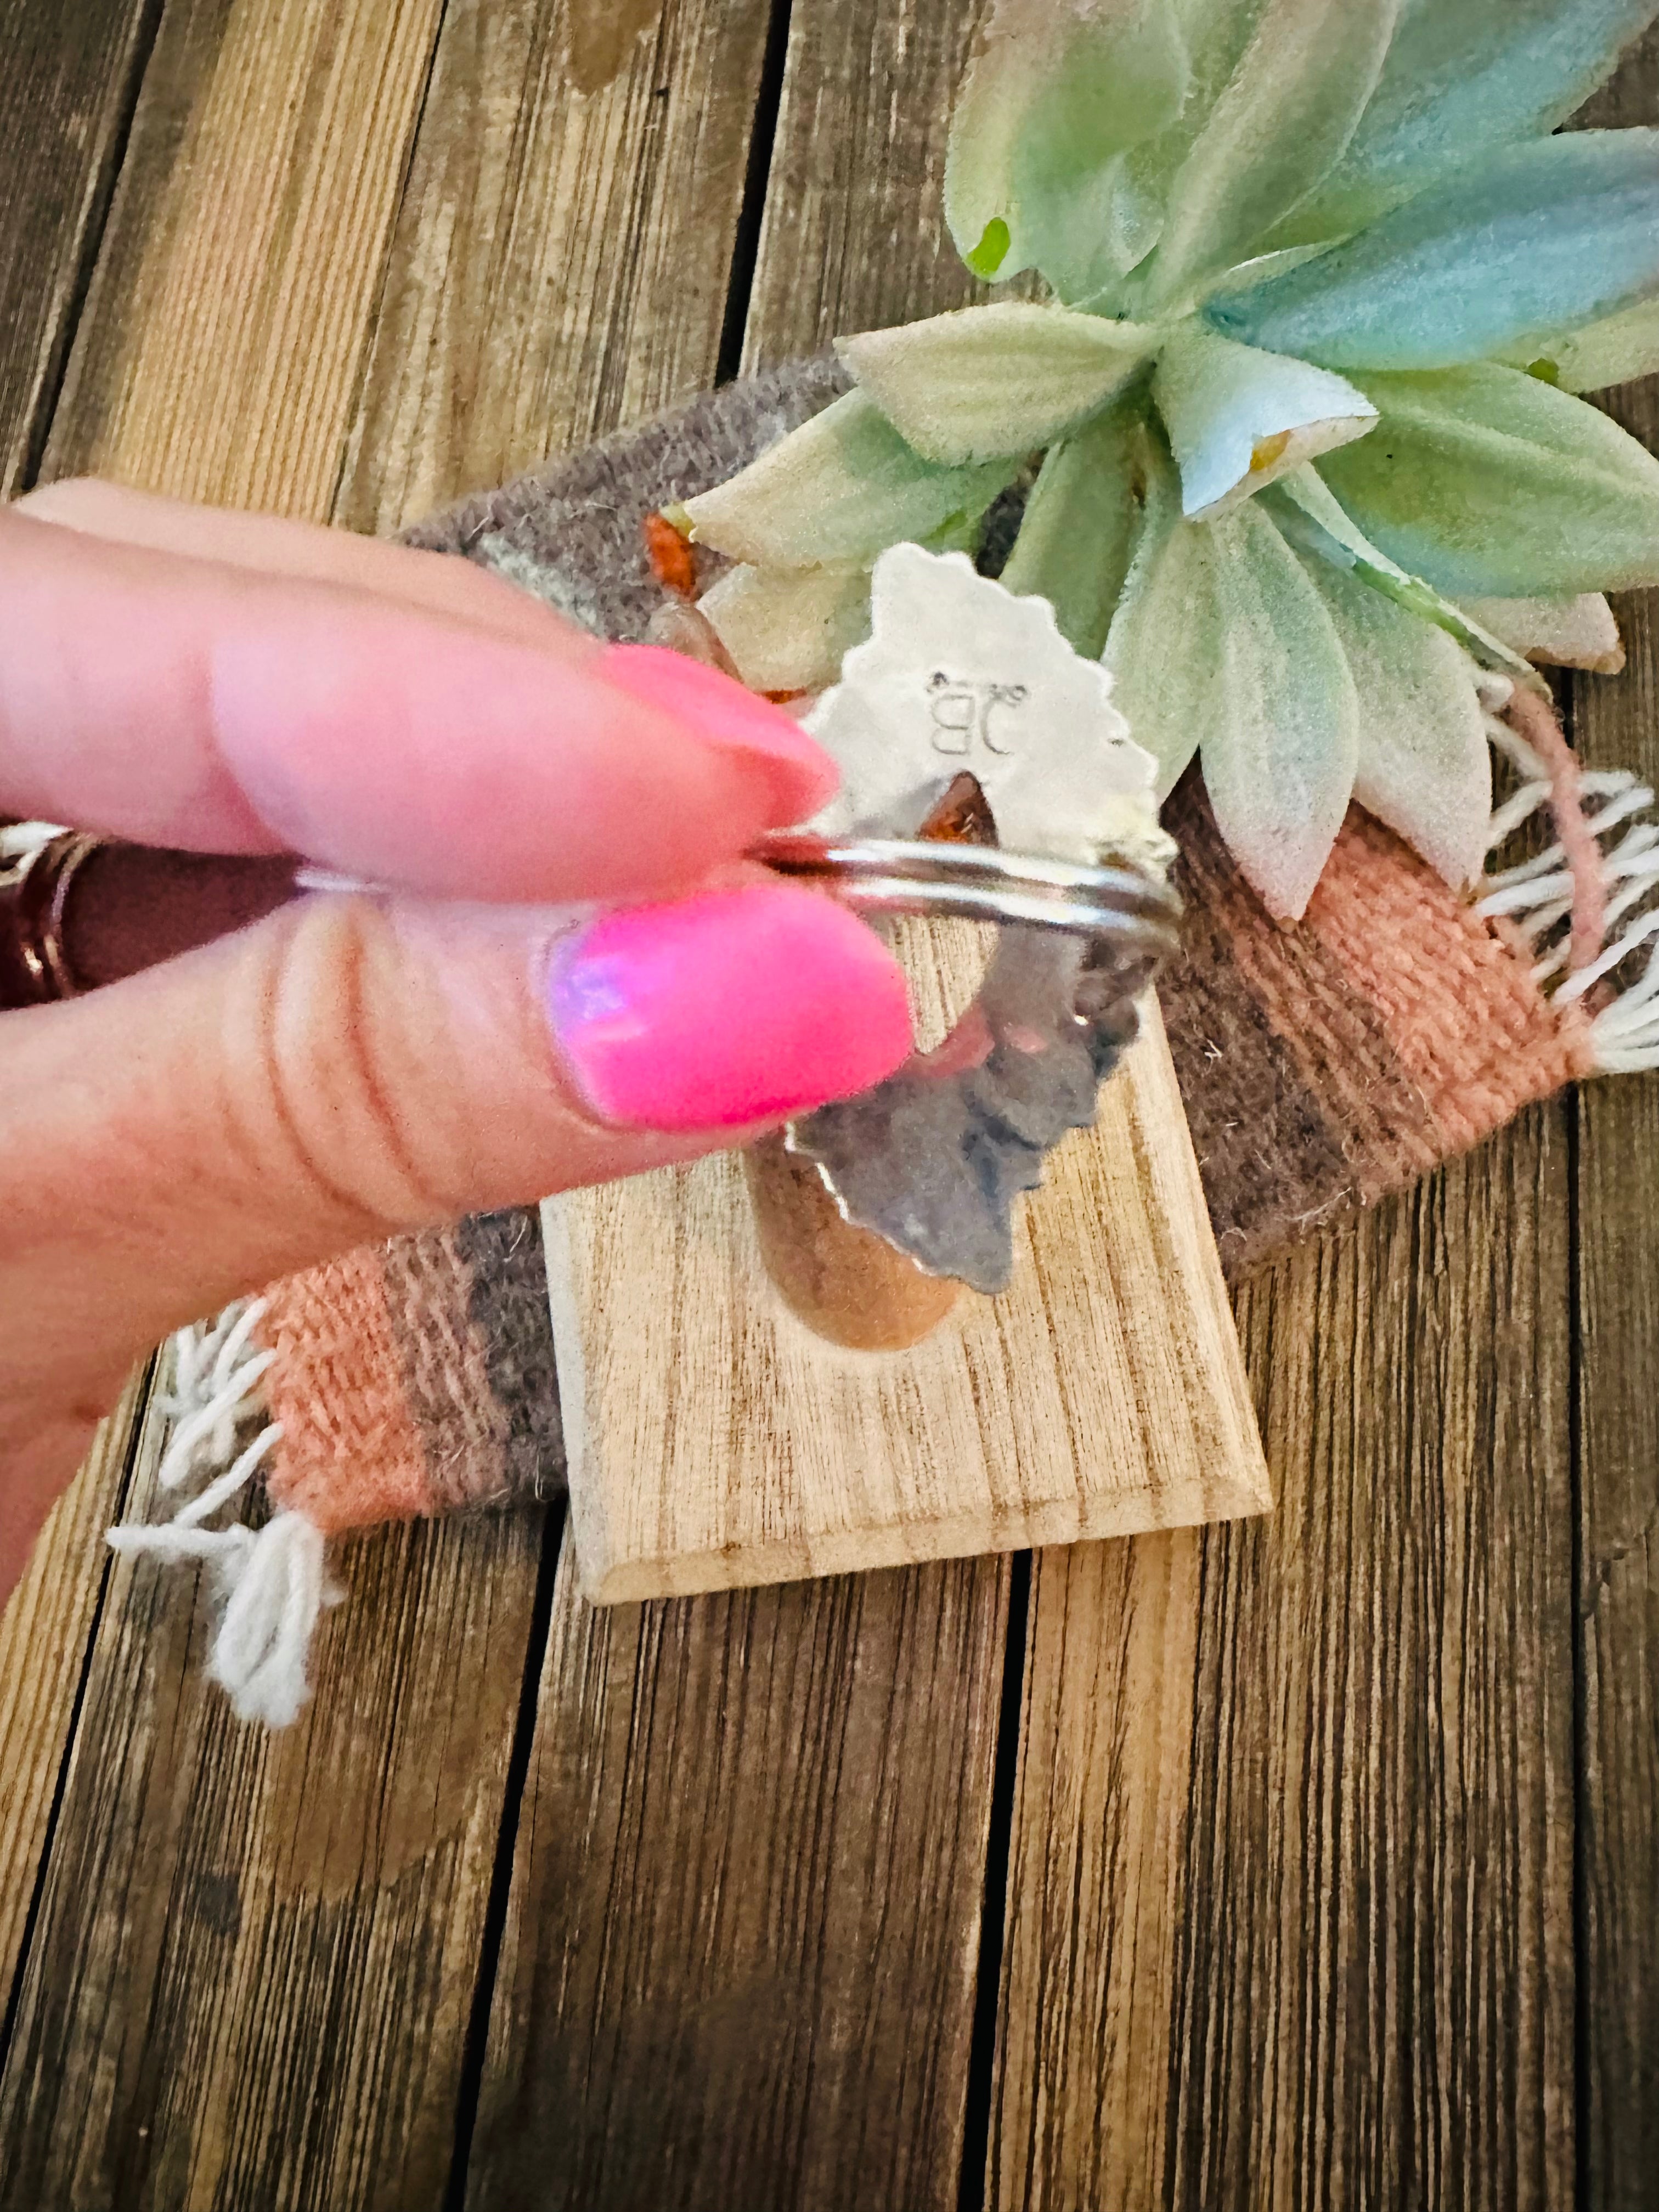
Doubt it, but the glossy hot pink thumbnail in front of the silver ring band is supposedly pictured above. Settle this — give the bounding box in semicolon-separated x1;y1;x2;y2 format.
549;885;911;1130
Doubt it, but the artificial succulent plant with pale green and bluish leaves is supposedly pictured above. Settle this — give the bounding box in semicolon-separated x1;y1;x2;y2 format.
677;0;1659;916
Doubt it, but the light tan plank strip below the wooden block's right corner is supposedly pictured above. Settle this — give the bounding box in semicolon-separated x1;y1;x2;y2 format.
986;1528;1201;2212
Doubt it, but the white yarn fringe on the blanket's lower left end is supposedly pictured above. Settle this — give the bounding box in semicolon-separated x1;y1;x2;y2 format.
109;1299;338;1728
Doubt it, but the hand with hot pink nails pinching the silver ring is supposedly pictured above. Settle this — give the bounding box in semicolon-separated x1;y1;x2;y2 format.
0;482;909;1595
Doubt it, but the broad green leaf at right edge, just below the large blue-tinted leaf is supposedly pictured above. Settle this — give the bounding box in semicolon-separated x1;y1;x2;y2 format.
1321;363;1659;600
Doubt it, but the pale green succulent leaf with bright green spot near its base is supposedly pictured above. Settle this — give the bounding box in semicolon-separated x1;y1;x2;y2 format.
945;0;1188;298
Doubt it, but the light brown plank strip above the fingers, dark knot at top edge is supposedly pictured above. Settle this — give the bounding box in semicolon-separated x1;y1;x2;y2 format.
336;0;783;533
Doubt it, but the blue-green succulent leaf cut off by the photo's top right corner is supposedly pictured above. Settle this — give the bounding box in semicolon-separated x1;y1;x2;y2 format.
1274;0;1659;246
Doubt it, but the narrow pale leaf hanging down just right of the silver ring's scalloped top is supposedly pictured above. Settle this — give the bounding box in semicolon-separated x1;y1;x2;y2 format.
1102;436;1226;801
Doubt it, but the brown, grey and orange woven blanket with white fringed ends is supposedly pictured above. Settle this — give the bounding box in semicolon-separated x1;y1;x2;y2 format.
120;360;1652;1721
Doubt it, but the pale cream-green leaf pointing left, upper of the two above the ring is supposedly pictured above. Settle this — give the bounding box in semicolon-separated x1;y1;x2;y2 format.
836;298;1157;465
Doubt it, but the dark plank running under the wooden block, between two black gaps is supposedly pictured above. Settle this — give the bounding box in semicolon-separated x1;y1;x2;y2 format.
467;0;1026;2212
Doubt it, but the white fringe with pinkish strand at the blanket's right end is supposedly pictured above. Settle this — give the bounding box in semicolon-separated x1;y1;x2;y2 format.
1475;714;1659;1075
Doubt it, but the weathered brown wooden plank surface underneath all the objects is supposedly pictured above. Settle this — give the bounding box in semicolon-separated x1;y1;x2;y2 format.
0;0;1659;2212
